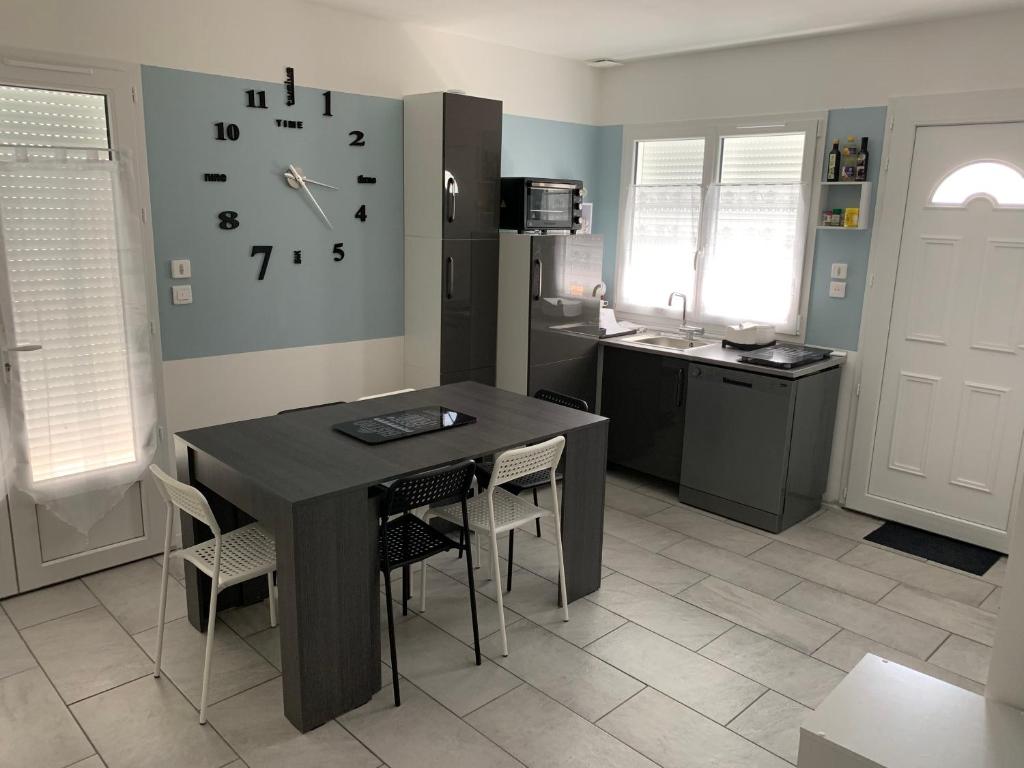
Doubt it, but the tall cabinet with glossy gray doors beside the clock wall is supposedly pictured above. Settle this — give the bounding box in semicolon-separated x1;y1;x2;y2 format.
404;93;502;388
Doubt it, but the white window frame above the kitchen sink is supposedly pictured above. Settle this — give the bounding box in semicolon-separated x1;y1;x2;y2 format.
614;112;827;341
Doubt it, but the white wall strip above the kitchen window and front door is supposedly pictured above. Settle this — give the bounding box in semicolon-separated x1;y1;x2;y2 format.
598;7;1024;124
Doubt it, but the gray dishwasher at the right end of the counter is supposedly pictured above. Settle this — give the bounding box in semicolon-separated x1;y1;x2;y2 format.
679;362;840;534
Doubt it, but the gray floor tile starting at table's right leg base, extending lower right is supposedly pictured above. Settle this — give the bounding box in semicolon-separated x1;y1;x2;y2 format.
587;573;732;650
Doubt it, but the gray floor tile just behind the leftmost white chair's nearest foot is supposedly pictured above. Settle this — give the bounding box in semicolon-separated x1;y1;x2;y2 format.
132;618;279;708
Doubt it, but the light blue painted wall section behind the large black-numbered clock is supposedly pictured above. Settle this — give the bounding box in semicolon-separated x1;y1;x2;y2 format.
142;67;404;359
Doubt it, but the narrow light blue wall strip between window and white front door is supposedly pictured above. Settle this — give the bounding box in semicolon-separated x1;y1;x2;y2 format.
807;106;886;349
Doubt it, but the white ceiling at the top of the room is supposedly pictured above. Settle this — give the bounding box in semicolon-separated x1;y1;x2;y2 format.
318;0;1024;59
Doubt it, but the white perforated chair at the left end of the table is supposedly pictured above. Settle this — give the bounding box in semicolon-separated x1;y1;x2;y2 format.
150;464;278;725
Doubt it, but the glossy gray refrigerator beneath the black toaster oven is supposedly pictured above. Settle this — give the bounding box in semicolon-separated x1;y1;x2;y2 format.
496;232;604;409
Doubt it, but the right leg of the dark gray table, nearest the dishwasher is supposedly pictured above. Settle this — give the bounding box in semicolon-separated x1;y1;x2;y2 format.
562;421;608;602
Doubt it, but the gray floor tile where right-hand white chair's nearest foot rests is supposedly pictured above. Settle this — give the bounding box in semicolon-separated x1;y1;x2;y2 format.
483;621;643;722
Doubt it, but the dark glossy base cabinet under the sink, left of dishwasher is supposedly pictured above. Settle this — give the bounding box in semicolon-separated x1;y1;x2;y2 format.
601;346;688;483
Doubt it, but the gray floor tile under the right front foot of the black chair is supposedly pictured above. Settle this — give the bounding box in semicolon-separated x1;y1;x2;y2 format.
381;616;520;717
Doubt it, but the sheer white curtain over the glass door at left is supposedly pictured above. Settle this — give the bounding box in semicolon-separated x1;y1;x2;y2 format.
0;151;158;534
